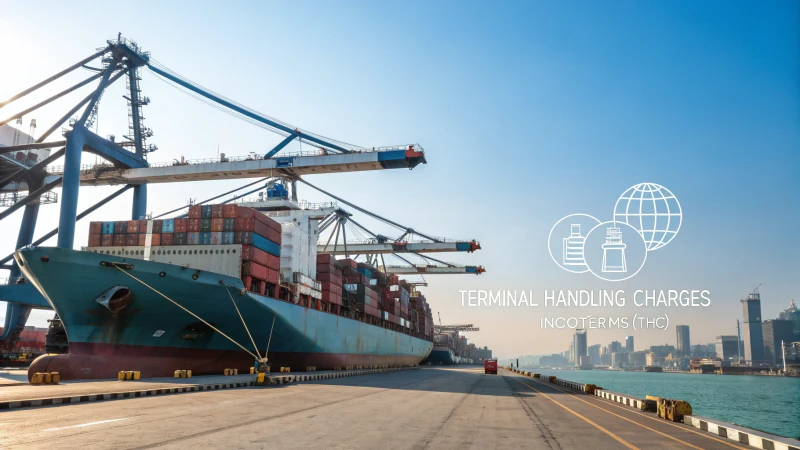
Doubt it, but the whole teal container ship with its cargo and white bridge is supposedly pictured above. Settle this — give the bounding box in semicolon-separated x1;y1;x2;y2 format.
15;199;433;379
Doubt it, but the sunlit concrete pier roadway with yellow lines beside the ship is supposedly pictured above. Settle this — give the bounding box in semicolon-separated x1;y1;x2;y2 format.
0;366;748;450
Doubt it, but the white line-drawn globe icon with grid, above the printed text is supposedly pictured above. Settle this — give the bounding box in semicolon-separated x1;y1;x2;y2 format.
614;183;682;251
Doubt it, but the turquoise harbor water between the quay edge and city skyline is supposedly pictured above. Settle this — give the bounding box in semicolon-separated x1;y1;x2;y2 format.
535;369;800;439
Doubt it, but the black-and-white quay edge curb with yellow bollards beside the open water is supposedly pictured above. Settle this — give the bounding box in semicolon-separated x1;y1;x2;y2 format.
500;366;800;450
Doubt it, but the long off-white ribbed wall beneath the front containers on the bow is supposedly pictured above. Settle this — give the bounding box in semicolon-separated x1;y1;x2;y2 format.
81;244;242;278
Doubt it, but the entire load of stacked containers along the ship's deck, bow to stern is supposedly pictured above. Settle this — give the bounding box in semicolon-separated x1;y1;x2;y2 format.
86;205;433;340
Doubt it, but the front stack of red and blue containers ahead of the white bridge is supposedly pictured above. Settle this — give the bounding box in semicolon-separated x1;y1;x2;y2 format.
87;205;281;297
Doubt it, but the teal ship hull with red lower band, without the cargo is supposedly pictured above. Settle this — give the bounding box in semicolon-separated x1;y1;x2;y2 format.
15;248;433;380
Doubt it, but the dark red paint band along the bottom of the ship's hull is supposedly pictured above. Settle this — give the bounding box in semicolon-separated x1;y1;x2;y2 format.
28;343;419;380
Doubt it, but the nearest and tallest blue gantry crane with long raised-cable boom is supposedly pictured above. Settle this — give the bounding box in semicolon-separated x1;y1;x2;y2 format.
0;35;426;340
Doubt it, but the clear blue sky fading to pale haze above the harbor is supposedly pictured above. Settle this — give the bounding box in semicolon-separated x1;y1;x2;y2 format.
0;1;800;355
